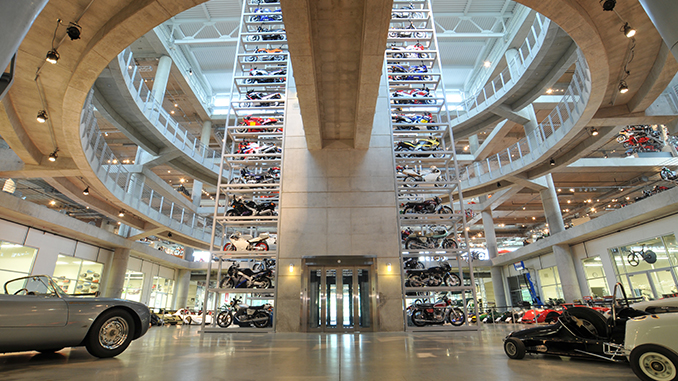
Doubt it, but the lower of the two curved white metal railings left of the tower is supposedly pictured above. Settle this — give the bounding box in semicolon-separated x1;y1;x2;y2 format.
80;91;221;244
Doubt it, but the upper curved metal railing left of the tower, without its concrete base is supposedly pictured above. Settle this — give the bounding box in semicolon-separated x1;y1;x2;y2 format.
118;47;221;173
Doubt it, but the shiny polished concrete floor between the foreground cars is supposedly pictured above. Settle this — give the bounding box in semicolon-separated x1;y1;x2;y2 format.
0;325;637;381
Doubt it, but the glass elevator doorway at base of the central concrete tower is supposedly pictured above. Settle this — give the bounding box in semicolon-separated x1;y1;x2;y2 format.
304;256;374;332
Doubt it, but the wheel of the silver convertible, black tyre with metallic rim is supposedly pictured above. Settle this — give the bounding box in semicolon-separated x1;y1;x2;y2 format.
85;309;135;358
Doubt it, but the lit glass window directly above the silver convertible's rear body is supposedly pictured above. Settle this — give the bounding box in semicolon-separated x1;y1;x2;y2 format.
53;255;104;295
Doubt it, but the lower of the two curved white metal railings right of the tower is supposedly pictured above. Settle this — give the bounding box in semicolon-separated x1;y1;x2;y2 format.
461;50;591;187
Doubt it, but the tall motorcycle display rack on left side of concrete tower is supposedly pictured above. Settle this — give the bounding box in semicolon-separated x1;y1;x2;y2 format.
202;0;289;332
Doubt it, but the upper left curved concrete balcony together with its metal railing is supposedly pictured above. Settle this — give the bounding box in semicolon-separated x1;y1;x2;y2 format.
95;47;221;185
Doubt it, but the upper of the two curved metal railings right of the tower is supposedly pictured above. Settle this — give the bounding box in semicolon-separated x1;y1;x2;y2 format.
451;13;551;120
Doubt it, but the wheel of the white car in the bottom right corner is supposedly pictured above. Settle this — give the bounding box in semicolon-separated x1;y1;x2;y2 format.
629;344;678;381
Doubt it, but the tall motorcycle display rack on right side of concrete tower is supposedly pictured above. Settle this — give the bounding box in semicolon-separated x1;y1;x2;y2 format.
385;0;478;330
